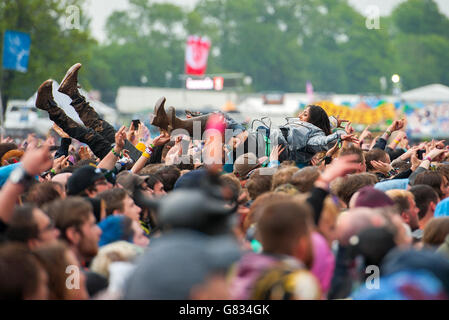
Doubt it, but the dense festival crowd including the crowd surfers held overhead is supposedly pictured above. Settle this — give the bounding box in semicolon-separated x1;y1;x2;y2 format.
0;64;449;300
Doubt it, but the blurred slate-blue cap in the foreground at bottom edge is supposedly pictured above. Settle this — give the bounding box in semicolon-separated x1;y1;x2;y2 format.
124;230;241;300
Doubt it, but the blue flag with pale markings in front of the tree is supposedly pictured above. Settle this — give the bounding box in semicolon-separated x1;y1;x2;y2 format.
3;30;31;72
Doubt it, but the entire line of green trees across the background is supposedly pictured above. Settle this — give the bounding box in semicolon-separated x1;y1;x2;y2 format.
0;0;449;103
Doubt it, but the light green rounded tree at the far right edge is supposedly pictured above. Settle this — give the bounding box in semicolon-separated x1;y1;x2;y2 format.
391;0;449;89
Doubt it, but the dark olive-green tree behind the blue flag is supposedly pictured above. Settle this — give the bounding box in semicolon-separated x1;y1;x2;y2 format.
0;0;95;114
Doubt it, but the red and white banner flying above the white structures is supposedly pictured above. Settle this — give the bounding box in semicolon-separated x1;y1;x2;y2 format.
185;36;210;76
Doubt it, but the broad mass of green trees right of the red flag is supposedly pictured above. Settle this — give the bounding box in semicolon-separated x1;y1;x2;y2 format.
195;0;391;92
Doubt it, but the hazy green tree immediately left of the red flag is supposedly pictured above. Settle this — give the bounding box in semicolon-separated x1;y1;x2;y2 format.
87;0;187;102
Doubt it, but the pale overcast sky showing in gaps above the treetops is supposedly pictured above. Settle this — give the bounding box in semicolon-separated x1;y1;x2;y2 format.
81;0;449;41
